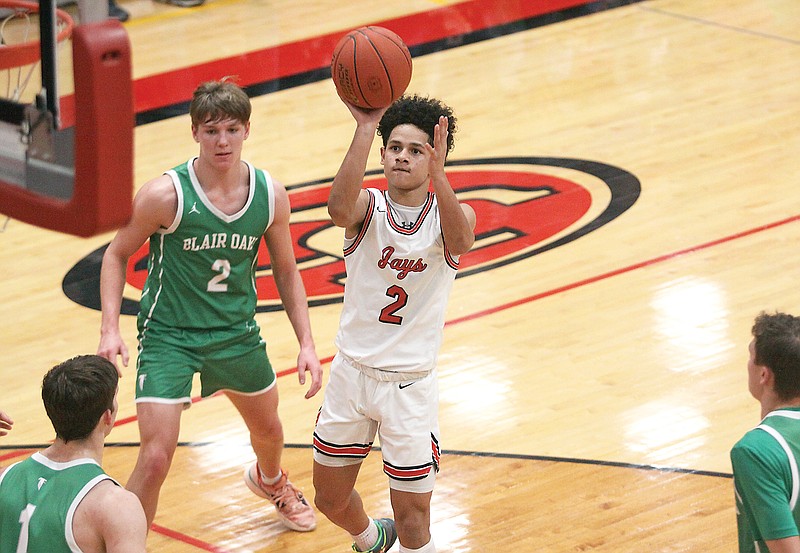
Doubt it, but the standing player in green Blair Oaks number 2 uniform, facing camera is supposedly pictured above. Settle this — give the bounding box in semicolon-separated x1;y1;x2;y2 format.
97;79;322;532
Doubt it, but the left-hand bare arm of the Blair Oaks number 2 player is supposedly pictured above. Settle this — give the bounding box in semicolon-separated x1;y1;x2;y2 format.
97;175;178;376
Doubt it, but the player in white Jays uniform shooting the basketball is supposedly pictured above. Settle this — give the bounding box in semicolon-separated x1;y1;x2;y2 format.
314;96;475;553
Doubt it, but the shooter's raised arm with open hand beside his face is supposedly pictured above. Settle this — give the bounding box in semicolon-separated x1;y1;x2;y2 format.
425;117;475;256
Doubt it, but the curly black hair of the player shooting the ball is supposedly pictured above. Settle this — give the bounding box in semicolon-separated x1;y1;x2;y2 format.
378;94;458;153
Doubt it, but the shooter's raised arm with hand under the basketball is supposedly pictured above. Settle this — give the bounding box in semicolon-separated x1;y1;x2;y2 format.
328;103;386;236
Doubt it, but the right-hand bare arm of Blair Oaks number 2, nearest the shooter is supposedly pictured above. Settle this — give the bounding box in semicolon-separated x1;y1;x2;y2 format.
264;181;322;399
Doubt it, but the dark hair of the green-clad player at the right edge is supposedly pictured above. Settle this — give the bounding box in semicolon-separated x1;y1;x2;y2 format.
752;313;800;400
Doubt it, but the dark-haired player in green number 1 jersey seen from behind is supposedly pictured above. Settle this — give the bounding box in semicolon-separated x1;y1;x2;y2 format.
0;355;147;553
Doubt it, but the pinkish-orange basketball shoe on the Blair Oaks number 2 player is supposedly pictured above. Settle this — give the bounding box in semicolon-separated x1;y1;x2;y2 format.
244;462;317;532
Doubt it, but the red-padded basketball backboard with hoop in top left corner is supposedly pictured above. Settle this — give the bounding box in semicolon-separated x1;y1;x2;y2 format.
0;0;134;236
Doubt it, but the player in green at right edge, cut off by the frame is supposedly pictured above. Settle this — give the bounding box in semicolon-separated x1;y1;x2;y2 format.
731;313;800;553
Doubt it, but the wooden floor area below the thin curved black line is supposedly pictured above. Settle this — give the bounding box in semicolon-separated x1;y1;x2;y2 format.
75;432;732;553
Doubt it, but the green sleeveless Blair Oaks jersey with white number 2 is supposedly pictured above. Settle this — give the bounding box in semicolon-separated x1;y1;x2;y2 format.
138;159;275;332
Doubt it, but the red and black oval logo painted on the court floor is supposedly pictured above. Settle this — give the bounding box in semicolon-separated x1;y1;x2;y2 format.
62;157;641;315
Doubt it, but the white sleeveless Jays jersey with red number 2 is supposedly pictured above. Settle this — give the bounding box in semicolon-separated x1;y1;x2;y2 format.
336;188;458;372
